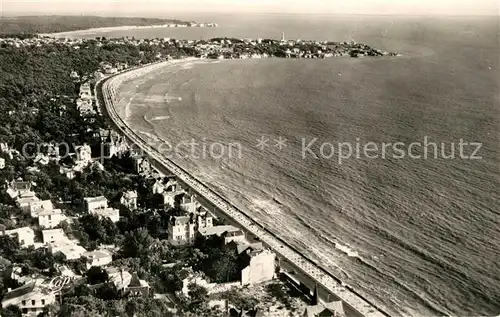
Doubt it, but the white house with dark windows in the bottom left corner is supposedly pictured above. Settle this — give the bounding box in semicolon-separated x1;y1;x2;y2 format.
2;282;56;316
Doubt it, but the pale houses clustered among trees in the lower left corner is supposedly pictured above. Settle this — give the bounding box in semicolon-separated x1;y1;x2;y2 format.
0;180;150;316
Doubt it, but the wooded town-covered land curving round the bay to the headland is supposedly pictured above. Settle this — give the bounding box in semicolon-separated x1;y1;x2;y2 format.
0;15;397;317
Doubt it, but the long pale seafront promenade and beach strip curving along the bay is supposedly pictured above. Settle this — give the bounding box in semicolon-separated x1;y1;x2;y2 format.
96;61;389;317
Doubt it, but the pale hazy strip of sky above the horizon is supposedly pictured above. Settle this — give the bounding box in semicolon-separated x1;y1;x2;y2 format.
0;0;500;17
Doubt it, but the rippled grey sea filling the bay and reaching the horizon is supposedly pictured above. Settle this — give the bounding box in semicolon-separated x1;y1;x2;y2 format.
82;14;500;316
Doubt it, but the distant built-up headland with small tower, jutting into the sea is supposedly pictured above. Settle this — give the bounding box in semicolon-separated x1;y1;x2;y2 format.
0;34;399;65
